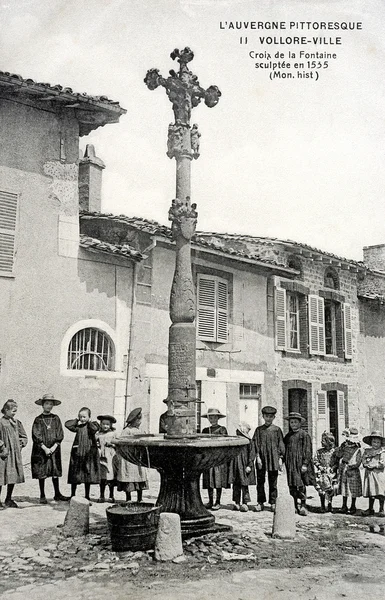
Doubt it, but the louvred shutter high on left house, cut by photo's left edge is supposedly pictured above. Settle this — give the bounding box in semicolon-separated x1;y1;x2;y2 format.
0;190;18;274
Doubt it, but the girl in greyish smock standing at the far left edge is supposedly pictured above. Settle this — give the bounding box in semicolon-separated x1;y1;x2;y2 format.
0;400;27;508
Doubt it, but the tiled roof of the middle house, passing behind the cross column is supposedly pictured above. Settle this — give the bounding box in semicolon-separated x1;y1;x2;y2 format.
80;211;288;270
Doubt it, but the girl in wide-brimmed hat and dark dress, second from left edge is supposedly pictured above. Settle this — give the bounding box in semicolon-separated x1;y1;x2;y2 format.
31;394;69;504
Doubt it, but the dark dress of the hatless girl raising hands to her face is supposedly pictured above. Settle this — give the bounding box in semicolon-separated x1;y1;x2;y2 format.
65;419;100;483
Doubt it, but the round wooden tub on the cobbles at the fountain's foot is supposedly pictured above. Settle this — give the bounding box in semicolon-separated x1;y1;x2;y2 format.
106;502;161;552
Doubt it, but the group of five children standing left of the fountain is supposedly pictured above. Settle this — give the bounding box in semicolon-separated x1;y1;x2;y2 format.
0;394;148;508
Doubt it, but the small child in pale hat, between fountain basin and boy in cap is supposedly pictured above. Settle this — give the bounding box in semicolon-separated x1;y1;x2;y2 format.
229;422;256;512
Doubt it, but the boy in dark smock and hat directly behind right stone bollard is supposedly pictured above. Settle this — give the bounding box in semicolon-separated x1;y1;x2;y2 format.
284;412;315;516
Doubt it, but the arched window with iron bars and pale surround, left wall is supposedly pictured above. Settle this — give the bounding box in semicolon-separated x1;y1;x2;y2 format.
67;327;115;371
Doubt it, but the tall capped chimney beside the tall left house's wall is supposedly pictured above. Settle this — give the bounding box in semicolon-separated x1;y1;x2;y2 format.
79;144;106;212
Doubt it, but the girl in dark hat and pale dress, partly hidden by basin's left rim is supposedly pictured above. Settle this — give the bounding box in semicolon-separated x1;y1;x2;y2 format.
114;408;148;502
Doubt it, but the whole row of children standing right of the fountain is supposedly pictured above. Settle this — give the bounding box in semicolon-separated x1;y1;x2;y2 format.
202;406;385;517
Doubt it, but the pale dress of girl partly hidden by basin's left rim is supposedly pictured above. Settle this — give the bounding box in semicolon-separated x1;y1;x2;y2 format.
113;427;148;492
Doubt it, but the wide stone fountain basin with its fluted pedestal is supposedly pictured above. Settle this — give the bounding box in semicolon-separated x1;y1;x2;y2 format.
115;435;249;537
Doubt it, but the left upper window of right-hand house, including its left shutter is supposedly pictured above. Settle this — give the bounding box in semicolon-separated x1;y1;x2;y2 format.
275;288;300;352
